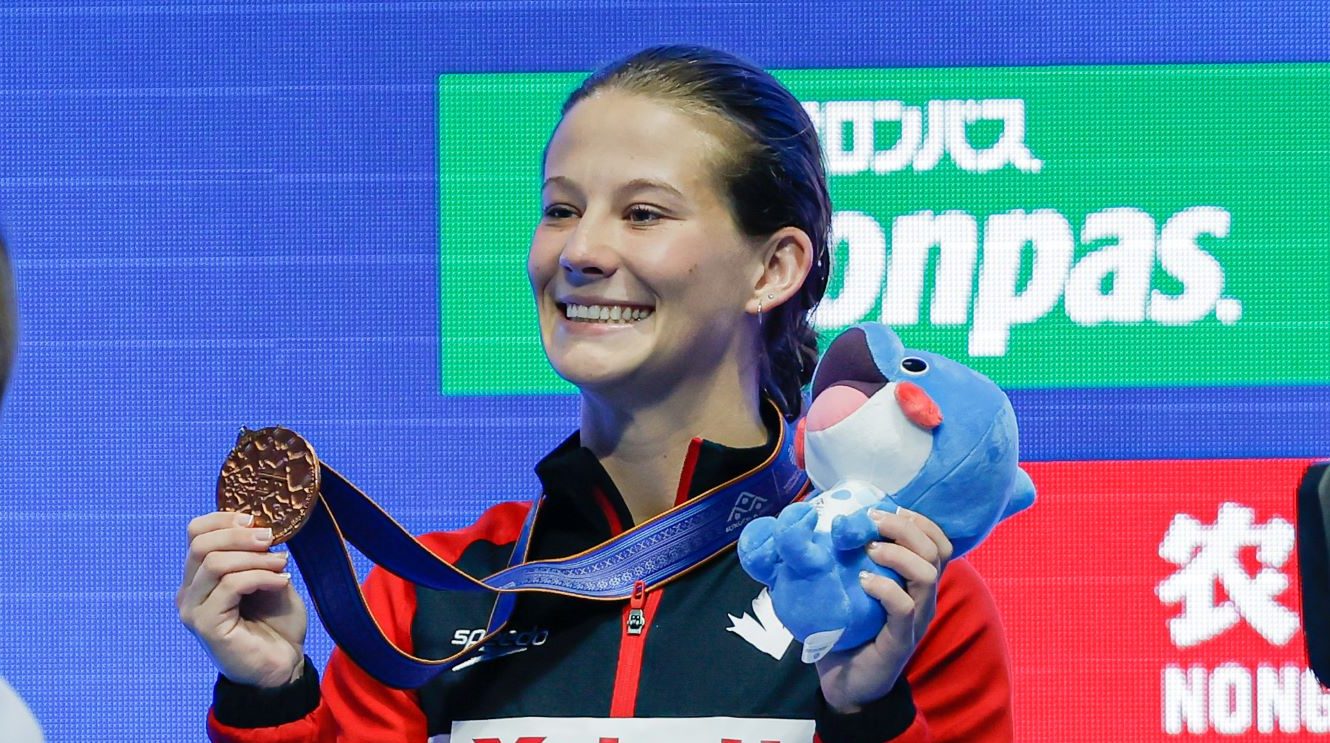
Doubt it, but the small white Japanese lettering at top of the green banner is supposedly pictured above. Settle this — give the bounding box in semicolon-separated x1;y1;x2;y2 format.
803;98;1044;175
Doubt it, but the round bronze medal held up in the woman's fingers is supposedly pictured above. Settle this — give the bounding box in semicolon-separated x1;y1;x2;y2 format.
217;427;319;545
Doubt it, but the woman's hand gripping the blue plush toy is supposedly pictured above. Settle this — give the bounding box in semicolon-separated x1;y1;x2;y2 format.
817;509;952;712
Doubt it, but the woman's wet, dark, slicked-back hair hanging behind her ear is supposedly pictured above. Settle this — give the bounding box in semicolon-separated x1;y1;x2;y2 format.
563;45;831;420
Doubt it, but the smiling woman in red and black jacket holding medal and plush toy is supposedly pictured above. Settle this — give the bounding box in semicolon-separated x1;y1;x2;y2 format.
177;47;1011;743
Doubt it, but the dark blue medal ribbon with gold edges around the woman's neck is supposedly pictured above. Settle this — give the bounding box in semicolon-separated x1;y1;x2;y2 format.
287;420;807;689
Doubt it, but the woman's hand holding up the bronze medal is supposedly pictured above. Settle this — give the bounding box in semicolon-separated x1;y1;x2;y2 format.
176;512;309;687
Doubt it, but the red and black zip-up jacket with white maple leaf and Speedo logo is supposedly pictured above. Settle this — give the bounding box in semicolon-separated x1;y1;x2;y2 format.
207;422;1012;743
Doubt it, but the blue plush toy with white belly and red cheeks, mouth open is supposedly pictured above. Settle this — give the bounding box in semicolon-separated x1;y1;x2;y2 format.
738;323;1035;663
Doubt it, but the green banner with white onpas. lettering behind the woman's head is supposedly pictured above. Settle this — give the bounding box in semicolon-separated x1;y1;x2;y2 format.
439;64;1330;395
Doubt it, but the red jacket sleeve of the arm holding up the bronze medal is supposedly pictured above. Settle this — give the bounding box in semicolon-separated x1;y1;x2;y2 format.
207;502;529;743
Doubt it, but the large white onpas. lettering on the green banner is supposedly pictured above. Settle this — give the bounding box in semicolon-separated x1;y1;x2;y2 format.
813;206;1242;356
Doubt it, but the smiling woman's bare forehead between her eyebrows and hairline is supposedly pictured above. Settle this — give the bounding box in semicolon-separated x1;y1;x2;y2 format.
545;90;726;194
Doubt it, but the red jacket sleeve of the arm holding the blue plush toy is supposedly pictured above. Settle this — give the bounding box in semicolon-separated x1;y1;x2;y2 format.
894;560;1016;743
